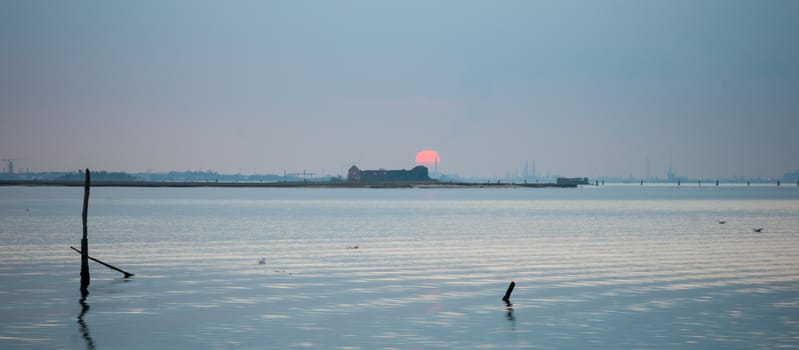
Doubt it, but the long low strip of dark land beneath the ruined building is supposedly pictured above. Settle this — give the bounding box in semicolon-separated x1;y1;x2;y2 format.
0;180;577;188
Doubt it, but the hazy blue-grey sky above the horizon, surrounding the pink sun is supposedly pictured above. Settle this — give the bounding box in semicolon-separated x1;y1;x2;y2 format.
0;0;799;178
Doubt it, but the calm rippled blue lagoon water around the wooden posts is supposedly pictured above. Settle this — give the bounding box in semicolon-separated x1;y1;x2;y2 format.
0;185;799;349
